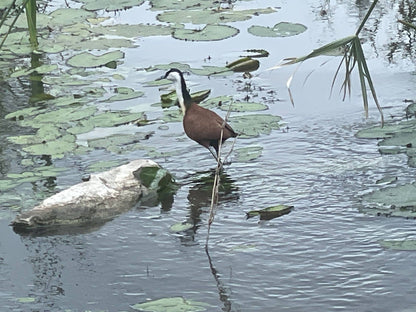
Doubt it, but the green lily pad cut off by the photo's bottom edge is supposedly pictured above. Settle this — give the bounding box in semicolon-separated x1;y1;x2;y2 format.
131;297;208;312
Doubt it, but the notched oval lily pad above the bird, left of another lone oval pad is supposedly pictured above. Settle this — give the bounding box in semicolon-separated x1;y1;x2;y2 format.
172;24;239;41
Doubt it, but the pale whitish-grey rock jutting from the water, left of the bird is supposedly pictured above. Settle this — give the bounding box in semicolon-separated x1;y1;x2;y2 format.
11;159;171;229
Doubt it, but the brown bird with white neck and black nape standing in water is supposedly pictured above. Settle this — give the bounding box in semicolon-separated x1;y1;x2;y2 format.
164;68;238;163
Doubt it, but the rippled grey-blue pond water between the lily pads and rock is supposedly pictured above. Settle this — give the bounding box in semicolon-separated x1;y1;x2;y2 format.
0;1;416;312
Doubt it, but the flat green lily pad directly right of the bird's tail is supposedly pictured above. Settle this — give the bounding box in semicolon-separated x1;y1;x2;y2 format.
229;114;281;138
